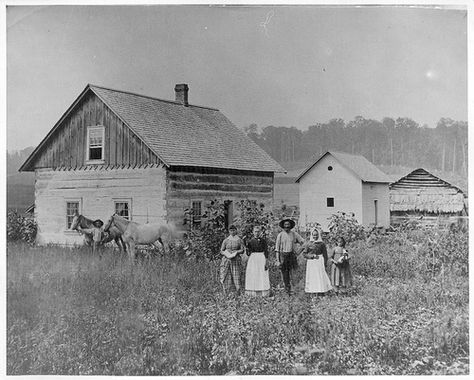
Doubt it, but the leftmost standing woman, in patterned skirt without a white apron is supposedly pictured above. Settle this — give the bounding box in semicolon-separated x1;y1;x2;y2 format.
220;225;244;295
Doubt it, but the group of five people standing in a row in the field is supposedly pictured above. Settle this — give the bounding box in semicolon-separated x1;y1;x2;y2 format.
220;219;352;296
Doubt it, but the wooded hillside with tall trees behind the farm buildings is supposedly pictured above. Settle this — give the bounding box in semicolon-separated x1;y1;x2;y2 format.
7;116;468;211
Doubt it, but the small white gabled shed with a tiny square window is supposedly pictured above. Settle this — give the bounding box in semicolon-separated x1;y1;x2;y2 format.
296;152;391;230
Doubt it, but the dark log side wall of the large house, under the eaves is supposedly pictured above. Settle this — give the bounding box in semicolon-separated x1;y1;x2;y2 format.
167;167;273;224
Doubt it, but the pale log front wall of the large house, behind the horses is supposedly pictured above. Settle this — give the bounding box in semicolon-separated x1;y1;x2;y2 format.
35;165;166;244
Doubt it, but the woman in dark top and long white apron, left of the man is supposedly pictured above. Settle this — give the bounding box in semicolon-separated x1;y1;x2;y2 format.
245;226;270;297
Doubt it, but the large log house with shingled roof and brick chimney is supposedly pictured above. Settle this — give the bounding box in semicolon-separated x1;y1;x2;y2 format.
20;84;285;244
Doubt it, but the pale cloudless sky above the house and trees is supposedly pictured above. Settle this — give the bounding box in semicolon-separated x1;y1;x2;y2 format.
6;5;468;151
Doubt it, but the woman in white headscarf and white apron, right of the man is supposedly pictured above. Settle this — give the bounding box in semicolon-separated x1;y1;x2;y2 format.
303;228;332;294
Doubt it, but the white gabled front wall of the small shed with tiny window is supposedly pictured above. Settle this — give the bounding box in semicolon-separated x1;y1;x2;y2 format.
299;155;362;230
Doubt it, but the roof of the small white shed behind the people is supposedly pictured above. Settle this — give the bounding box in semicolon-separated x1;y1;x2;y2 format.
296;151;392;183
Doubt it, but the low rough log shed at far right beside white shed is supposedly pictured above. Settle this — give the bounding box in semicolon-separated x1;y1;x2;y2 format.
390;168;467;224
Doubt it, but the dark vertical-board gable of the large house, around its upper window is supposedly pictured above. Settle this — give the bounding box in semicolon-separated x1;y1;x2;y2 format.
35;91;160;168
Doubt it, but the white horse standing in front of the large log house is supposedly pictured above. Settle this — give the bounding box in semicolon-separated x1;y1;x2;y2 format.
104;214;179;259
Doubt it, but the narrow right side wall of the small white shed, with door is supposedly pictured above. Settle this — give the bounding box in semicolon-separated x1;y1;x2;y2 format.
362;182;390;227
